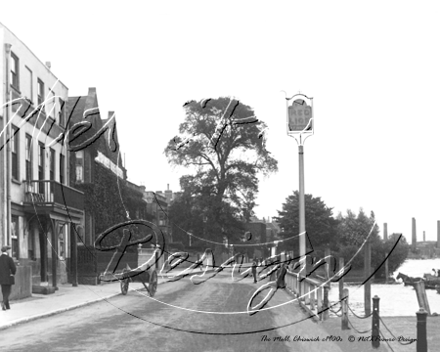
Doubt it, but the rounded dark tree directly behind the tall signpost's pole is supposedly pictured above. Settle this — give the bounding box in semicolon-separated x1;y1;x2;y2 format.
275;191;338;255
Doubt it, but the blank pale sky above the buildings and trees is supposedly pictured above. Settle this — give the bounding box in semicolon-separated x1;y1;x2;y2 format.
0;0;440;245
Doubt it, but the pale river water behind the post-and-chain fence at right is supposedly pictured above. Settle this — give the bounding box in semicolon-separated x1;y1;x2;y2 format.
329;259;440;316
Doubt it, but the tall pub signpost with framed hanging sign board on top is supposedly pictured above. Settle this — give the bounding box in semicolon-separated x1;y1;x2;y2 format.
286;93;314;259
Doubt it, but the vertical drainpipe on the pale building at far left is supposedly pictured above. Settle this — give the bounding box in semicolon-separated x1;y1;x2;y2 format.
3;43;12;245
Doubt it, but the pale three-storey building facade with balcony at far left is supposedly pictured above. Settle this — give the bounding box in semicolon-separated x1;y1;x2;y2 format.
0;24;84;287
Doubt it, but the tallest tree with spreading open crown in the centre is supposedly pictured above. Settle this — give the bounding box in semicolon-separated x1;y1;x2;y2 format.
165;98;277;248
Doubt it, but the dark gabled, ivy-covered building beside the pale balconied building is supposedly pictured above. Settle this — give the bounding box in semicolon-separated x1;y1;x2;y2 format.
68;88;152;284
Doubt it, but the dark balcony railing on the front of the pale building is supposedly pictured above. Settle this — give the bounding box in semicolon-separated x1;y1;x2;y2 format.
24;181;84;210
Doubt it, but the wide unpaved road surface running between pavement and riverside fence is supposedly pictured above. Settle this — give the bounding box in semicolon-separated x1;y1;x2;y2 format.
0;272;340;352
